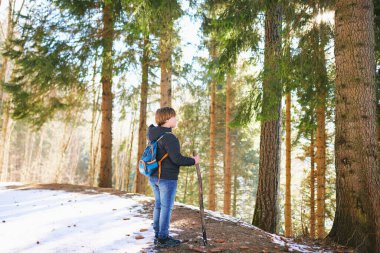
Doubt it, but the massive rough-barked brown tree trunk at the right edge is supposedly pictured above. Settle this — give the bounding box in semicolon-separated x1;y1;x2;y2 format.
328;0;380;253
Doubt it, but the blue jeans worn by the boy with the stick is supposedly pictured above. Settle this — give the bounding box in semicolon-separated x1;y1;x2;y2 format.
149;177;177;239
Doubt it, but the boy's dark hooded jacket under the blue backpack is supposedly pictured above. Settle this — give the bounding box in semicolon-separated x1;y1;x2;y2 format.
148;125;195;180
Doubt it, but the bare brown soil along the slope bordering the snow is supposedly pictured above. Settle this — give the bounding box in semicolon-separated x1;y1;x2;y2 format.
4;184;355;253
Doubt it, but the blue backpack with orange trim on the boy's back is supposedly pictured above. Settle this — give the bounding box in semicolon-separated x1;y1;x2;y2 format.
139;132;170;178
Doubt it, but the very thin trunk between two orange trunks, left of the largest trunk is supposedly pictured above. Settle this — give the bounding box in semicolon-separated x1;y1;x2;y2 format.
310;130;315;239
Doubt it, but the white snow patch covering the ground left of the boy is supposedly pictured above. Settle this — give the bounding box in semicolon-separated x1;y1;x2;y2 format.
0;183;154;253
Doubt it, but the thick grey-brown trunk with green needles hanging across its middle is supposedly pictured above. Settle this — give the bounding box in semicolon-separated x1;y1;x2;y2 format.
252;1;282;233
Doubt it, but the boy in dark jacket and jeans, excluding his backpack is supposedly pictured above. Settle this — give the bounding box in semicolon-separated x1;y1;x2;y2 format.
148;107;199;247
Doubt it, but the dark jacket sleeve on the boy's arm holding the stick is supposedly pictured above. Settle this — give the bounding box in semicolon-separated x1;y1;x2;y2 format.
164;134;195;166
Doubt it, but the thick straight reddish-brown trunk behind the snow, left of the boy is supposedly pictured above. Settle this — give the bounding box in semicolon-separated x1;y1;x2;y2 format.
99;1;114;188
